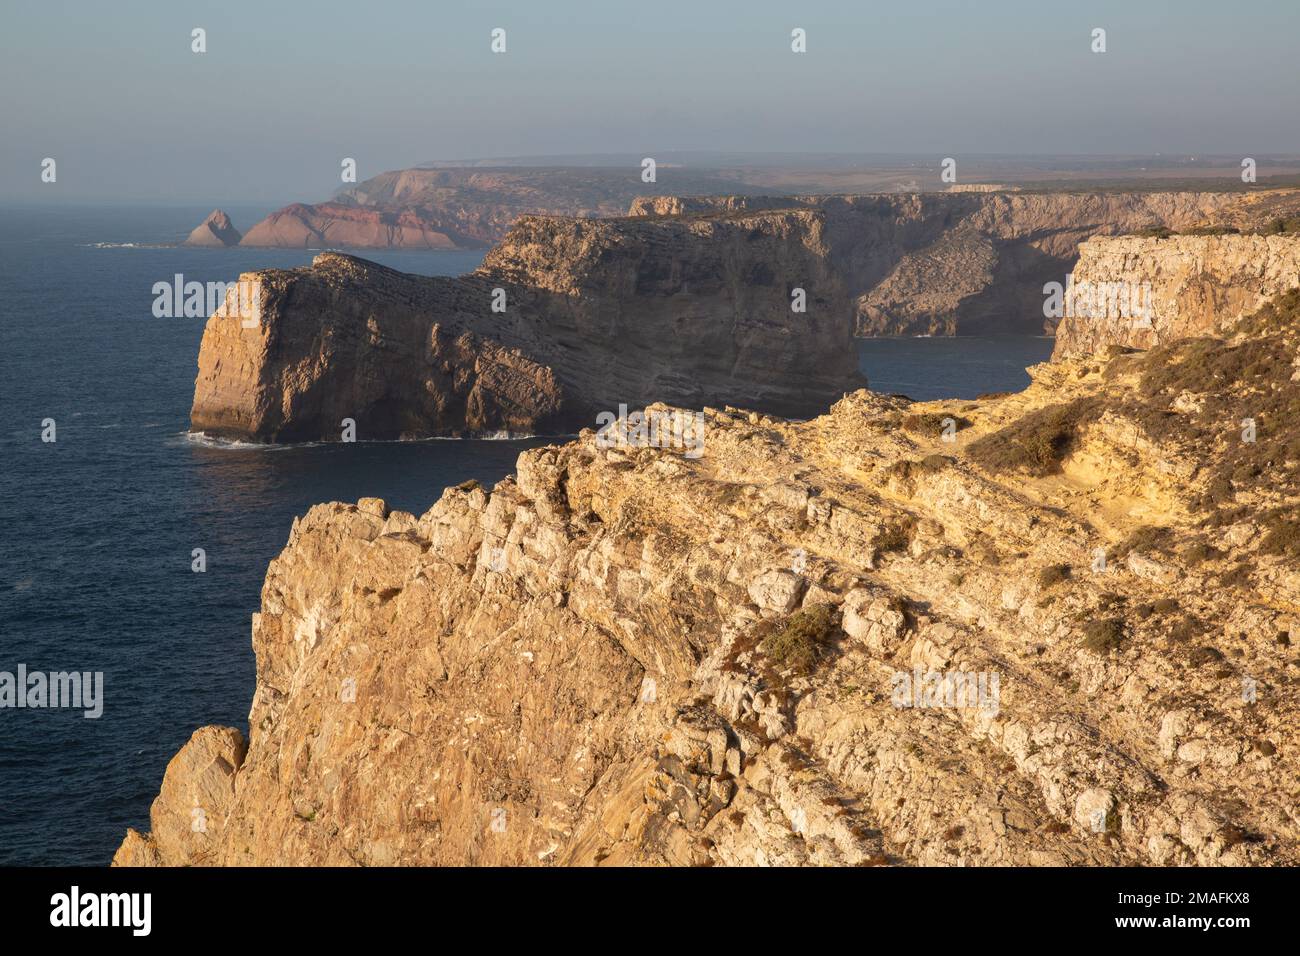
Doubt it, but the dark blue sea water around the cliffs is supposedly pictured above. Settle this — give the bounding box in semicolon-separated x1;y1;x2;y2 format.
0;207;1050;865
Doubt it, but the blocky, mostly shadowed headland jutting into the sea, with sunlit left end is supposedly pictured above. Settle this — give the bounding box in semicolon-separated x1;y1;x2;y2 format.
191;209;861;441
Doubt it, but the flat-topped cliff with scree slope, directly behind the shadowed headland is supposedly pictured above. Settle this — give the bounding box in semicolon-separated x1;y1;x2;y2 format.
631;190;1300;336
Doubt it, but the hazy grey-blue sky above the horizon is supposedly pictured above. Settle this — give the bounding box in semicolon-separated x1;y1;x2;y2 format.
0;0;1300;203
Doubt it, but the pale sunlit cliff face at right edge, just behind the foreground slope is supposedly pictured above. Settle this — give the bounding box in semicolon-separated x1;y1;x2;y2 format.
1052;235;1300;358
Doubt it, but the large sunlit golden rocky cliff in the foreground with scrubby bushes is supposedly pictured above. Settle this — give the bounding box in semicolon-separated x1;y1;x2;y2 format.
122;290;1300;865
